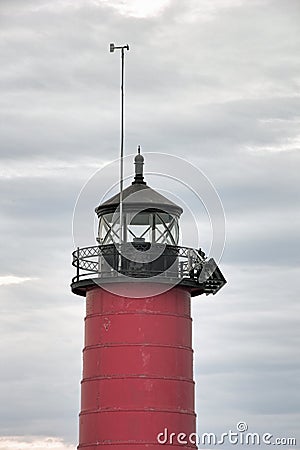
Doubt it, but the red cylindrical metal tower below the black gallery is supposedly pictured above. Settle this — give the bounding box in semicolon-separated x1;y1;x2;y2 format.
79;286;195;450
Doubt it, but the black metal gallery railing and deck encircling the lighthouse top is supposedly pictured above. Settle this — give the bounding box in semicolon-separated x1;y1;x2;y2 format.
72;242;226;294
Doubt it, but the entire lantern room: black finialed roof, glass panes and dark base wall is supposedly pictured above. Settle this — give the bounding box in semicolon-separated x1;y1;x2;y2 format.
96;148;183;278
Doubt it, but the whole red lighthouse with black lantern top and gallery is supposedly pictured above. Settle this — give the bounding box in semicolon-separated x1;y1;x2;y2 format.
71;149;226;450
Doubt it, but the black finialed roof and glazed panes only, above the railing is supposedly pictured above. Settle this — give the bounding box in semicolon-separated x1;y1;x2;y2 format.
96;149;183;246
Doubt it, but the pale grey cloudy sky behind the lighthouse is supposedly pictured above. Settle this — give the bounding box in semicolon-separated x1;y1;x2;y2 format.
0;0;300;450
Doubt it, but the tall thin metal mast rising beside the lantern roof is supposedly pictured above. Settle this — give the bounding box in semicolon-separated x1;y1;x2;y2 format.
109;43;129;250
